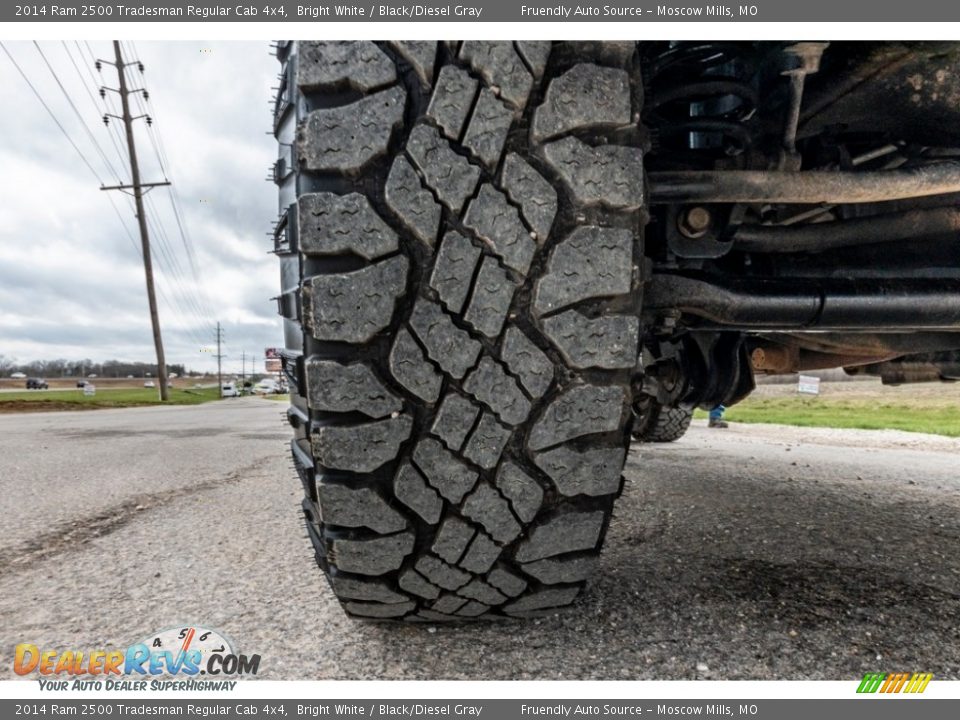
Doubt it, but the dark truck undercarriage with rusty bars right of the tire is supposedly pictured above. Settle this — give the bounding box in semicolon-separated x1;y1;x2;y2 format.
640;42;960;416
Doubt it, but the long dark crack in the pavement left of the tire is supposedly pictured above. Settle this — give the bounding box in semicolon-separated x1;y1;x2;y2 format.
0;457;272;575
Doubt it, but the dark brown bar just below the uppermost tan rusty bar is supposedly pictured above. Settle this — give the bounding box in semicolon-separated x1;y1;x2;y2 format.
733;207;960;253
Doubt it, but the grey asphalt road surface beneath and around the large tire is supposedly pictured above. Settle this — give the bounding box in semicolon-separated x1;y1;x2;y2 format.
0;398;960;679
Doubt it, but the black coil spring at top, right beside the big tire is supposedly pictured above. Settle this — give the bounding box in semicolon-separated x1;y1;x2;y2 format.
645;42;758;157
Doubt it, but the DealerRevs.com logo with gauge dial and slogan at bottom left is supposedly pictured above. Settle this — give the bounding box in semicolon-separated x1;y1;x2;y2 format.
13;625;260;690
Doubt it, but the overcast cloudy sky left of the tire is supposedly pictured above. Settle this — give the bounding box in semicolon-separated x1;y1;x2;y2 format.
0;41;282;371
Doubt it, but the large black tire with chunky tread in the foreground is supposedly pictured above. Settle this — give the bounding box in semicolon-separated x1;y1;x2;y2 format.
275;42;646;621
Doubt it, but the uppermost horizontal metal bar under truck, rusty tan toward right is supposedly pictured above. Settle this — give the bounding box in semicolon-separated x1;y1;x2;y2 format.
649;162;960;205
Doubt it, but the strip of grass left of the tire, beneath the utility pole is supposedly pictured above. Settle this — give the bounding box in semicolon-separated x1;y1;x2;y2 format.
0;387;220;413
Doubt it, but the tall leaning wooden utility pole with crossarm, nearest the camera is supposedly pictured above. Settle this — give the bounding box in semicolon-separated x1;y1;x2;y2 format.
97;40;170;402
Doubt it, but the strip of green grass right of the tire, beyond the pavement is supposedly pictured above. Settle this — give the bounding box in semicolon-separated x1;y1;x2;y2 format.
695;395;960;437
